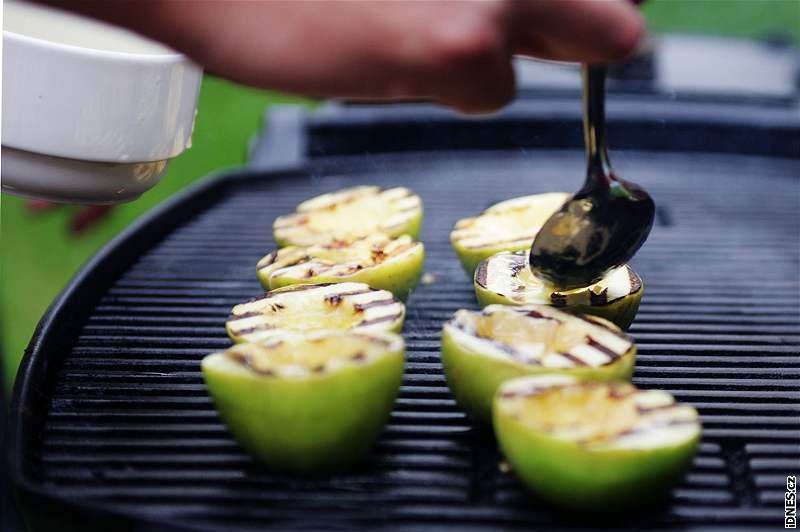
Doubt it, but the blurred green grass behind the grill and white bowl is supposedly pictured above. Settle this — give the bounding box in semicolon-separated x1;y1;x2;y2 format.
0;0;800;389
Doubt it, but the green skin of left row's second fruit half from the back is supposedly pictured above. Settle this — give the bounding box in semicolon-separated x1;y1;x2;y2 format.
258;245;425;301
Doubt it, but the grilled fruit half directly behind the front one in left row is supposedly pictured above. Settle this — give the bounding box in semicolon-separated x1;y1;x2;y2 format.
225;283;406;342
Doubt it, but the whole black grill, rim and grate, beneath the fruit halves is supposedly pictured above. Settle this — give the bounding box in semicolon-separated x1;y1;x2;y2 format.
9;50;800;530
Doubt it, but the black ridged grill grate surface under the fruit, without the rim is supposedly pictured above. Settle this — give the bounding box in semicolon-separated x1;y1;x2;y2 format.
10;145;800;530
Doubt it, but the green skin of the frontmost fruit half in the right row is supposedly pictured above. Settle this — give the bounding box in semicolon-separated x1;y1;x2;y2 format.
493;401;700;513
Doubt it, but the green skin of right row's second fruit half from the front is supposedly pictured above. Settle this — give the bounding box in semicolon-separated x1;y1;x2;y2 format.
442;326;636;425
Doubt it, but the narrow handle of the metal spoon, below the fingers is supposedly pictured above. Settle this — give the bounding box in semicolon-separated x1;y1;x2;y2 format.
581;64;611;188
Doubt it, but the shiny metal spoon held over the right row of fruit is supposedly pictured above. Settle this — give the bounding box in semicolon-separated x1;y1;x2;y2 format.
530;65;656;290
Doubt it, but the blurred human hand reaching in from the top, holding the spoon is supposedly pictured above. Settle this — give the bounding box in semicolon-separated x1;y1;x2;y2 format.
46;0;644;112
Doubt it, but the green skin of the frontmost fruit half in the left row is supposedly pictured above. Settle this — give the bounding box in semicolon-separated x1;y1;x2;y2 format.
203;350;404;475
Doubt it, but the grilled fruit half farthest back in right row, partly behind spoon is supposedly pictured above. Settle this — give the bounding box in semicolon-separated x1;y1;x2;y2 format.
450;192;570;276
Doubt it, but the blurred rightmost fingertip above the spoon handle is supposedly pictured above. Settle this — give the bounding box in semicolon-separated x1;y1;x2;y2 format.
510;0;644;63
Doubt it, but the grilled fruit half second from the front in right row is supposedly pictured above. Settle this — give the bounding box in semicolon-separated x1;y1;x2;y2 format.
442;305;636;423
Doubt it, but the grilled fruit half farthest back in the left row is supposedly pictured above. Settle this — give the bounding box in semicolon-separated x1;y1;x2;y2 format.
272;186;422;246
